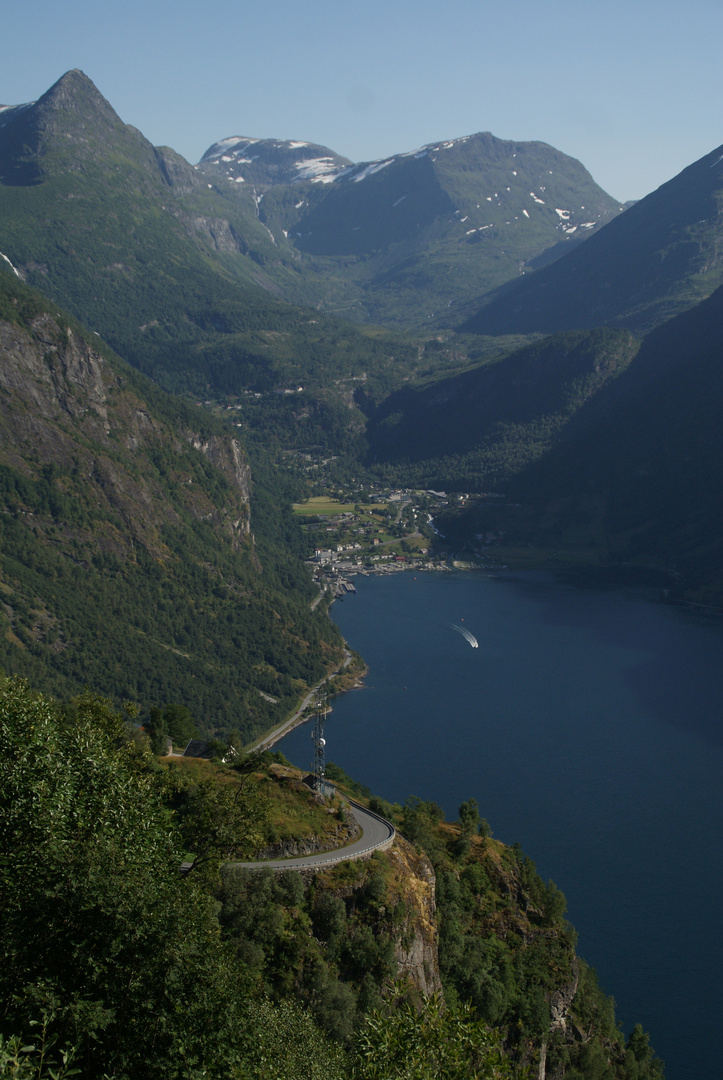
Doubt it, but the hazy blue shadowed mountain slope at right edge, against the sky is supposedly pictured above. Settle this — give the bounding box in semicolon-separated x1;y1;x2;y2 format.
460;146;723;334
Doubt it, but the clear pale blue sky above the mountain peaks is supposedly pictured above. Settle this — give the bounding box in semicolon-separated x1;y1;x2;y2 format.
0;0;723;201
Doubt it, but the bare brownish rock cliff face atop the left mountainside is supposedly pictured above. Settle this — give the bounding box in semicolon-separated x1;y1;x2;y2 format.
0;312;251;557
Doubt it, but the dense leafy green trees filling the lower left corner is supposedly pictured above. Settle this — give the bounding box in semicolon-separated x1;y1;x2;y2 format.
0;680;258;1080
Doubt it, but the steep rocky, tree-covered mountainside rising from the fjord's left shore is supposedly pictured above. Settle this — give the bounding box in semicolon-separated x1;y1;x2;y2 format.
0;270;340;739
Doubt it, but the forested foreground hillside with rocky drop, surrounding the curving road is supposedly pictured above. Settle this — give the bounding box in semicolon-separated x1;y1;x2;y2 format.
0;680;661;1080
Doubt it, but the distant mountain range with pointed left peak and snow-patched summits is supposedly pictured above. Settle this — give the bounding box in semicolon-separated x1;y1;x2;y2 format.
0;70;620;362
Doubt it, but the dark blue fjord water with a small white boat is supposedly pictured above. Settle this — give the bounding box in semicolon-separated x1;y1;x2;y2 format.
280;573;723;1080
